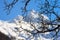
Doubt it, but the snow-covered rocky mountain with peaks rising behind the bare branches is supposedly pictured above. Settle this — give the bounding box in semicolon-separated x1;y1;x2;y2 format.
0;10;58;40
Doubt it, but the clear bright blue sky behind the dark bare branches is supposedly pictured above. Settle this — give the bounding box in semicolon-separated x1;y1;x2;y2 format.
0;0;60;20
